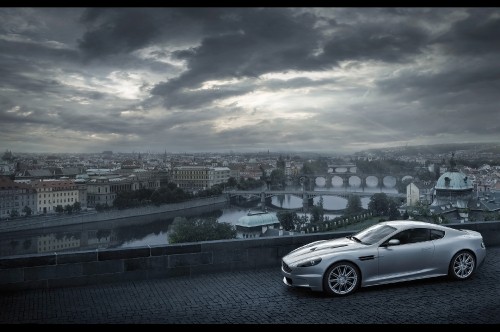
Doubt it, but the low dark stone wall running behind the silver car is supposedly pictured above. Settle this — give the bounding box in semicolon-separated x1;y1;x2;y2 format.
0;221;500;291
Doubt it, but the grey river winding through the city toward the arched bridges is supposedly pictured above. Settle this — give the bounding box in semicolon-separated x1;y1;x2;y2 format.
0;187;398;257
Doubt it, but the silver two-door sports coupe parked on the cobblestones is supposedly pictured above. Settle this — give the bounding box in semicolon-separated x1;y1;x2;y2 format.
281;220;486;296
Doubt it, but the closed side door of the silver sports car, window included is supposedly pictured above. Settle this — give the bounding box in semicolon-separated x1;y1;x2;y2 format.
378;228;434;282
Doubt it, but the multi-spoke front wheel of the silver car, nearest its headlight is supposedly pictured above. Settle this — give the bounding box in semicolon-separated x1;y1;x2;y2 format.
323;262;361;296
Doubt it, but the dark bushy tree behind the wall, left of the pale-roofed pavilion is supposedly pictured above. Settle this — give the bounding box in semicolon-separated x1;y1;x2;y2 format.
168;218;236;243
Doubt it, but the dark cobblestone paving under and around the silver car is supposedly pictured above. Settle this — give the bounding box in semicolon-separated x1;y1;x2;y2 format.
0;247;500;324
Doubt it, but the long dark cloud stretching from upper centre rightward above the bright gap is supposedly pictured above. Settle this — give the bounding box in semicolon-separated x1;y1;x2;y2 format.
151;10;438;107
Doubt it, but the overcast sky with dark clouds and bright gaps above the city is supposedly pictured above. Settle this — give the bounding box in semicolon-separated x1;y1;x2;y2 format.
0;7;500;153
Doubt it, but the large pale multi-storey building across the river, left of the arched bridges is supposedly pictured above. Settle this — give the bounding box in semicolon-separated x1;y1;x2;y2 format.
172;166;231;192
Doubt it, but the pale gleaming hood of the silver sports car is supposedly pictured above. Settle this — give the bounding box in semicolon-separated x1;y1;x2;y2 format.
283;237;366;264
